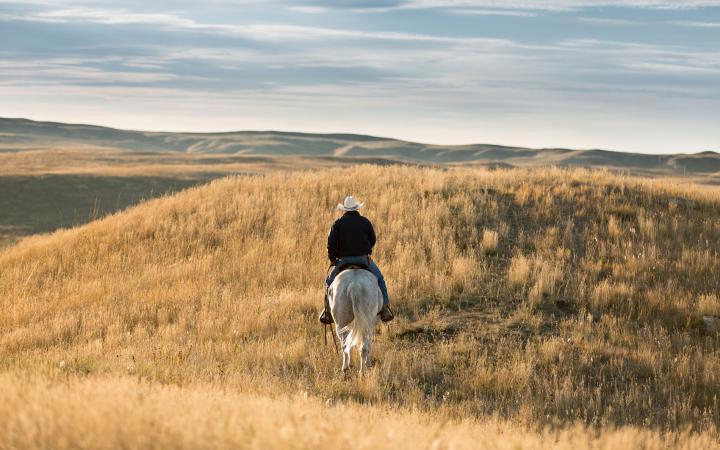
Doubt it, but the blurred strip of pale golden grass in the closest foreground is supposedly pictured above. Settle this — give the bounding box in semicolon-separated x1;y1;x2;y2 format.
0;376;720;450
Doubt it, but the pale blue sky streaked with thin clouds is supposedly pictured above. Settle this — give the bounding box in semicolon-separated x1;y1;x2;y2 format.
0;0;720;153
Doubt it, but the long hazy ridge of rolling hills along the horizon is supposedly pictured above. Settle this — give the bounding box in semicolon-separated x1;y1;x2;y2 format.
0;118;720;175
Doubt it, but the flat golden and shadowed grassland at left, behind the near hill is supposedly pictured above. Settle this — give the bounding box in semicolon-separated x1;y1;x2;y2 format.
0;149;400;247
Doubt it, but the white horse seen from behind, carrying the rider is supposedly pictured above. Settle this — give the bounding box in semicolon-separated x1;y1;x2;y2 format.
330;269;382;375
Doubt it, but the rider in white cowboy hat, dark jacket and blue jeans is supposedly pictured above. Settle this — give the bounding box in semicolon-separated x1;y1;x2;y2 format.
320;195;394;324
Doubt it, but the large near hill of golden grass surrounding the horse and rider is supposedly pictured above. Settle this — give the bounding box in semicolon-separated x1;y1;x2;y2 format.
0;165;720;448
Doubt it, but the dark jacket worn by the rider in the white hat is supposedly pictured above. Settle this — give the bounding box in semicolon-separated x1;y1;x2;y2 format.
328;211;375;262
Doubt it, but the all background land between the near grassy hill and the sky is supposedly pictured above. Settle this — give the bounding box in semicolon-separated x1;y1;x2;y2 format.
5;118;720;247
